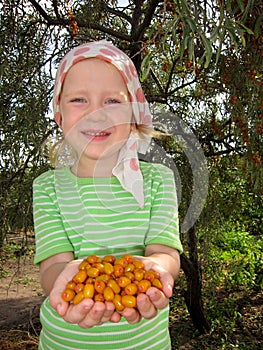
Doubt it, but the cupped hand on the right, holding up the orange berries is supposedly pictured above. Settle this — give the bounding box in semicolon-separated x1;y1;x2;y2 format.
121;256;174;324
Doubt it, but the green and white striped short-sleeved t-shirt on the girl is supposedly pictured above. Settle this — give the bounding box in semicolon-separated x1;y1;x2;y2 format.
33;162;182;350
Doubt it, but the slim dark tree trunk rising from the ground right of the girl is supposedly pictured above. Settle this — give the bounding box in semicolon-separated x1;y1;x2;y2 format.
181;227;210;334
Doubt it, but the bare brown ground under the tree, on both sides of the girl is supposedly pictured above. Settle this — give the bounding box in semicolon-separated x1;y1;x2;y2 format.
0;238;263;350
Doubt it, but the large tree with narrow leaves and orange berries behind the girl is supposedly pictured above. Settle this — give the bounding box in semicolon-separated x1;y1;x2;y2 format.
0;0;263;331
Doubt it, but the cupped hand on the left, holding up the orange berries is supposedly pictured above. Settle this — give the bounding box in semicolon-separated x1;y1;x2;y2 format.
49;260;121;328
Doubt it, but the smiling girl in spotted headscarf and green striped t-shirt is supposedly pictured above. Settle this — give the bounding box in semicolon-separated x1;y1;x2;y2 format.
33;41;182;350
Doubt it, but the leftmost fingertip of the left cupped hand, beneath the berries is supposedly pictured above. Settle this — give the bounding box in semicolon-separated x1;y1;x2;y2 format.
64;298;94;324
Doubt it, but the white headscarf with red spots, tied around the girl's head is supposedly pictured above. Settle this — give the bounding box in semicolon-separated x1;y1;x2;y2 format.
53;40;152;207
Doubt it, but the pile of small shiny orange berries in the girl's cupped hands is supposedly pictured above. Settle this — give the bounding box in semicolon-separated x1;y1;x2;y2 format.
62;254;162;311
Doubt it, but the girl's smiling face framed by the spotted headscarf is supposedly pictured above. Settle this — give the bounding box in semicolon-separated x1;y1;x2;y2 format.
57;58;132;165
